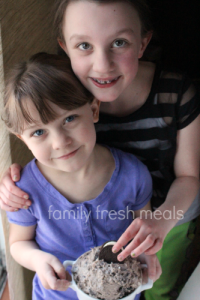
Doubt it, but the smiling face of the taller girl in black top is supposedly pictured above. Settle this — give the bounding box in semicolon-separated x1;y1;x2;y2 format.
60;1;151;102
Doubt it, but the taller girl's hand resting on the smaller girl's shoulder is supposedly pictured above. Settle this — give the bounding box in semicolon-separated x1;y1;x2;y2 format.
0;164;31;211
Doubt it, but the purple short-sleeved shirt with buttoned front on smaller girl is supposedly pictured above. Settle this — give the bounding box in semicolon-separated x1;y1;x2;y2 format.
7;148;152;300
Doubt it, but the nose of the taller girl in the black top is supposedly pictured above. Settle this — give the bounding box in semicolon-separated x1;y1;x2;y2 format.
93;50;114;75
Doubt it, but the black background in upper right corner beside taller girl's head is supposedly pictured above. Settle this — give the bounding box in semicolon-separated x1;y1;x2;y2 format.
147;0;200;81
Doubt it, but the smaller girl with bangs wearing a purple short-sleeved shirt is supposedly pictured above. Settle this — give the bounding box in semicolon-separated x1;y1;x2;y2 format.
3;53;152;300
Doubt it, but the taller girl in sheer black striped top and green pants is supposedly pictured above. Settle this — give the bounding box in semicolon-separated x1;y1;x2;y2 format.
0;0;200;300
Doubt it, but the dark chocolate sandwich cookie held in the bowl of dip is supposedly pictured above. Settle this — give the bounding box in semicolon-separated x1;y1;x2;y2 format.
99;241;123;264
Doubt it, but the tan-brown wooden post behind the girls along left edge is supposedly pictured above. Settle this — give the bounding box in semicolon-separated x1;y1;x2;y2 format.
0;0;57;300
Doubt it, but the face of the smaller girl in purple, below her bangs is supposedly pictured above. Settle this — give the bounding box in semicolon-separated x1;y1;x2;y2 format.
18;101;99;172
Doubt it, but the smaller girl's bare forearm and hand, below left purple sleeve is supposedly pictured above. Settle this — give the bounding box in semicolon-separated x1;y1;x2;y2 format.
9;224;70;291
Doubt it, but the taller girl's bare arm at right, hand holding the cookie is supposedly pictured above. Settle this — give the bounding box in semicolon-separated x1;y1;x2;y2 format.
113;116;200;260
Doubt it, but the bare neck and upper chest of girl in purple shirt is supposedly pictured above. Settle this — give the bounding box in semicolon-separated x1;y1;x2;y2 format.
37;145;115;203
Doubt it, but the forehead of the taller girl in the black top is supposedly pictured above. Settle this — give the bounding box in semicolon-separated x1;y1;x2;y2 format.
63;1;141;39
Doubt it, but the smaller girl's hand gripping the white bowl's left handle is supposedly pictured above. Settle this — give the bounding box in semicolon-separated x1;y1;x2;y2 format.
33;250;71;291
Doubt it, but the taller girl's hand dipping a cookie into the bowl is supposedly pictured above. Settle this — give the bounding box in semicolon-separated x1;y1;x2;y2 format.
112;214;170;261
